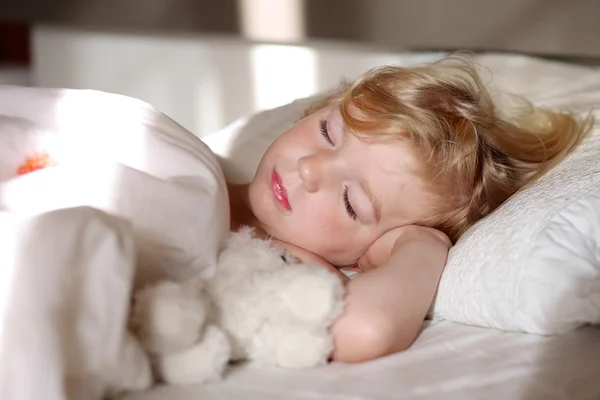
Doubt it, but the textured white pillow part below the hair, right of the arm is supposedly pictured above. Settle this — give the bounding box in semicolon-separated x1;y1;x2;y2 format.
433;127;600;334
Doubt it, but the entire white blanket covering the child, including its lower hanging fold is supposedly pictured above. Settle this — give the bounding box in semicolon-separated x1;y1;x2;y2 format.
0;87;229;400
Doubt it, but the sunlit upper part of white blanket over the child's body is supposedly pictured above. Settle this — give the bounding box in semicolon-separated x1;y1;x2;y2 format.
0;86;229;283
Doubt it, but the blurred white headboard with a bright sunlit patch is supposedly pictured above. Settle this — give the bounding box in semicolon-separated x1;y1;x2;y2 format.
32;26;446;136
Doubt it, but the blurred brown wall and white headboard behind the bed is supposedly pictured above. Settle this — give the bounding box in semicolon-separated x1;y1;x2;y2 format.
0;0;600;136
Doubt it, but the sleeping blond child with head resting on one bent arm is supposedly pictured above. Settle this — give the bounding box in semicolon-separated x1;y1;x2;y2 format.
221;57;590;362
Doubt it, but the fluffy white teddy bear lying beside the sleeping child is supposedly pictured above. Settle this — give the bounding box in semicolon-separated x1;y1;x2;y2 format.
131;229;344;384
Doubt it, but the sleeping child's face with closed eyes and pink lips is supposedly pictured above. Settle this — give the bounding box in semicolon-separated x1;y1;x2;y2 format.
249;107;432;266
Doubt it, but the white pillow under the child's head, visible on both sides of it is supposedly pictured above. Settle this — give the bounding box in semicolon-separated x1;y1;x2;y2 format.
205;54;600;334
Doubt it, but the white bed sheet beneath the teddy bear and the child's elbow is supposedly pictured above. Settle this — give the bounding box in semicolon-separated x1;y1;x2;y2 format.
124;321;600;400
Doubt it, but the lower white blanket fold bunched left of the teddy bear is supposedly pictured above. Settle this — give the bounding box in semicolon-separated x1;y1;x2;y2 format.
0;208;151;400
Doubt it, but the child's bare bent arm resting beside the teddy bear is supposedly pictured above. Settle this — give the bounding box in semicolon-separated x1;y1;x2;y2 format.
332;226;450;362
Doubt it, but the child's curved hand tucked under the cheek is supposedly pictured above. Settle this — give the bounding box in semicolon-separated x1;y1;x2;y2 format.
358;225;452;271
